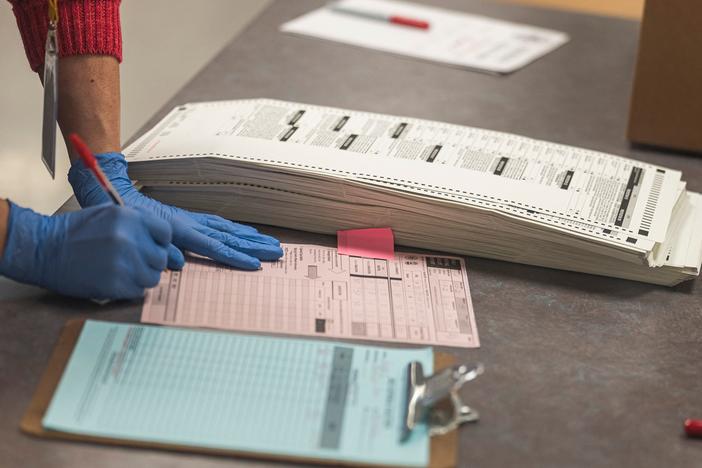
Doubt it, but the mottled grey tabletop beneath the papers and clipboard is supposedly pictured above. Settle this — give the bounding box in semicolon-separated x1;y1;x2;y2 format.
0;0;702;468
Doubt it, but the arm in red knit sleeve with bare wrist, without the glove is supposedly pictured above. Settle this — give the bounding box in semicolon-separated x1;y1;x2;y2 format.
10;0;122;160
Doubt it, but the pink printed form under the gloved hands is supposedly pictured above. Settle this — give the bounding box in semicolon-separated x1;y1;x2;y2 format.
141;244;480;348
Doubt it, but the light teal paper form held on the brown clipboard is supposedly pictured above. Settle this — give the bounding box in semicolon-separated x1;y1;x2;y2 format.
42;320;434;466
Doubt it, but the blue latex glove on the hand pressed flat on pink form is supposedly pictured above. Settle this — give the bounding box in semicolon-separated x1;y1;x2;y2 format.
68;153;283;270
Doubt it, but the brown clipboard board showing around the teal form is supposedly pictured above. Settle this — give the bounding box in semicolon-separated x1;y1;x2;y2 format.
20;319;458;468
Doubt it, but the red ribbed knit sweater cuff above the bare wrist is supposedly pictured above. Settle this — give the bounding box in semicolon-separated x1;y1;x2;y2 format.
10;0;122;71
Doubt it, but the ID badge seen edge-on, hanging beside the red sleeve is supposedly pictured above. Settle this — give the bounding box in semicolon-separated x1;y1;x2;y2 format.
41;0;58;179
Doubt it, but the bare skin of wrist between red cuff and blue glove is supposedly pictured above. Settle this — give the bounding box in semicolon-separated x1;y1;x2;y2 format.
58;55;120;161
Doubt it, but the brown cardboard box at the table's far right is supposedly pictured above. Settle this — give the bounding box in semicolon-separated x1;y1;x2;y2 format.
628;0;702;153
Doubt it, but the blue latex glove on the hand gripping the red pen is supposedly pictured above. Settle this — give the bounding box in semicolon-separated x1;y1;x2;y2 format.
0;203;171;299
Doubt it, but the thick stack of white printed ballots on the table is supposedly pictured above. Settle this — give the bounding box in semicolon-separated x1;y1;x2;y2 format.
125;99;702;285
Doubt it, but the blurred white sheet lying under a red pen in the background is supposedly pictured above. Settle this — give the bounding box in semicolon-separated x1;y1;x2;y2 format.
281;0;568;73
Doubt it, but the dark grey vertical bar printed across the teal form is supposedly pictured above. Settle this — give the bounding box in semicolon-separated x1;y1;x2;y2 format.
319;346;353;449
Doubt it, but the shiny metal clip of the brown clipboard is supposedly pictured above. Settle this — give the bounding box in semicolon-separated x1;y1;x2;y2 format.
401;361;484;441
